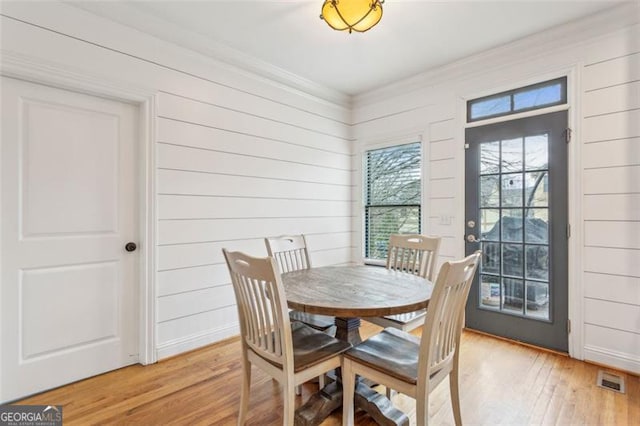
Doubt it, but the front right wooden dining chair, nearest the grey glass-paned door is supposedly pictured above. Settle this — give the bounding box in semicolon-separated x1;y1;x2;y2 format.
342;251;480;426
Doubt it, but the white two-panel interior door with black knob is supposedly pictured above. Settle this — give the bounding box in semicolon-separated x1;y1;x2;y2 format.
0;77;139;401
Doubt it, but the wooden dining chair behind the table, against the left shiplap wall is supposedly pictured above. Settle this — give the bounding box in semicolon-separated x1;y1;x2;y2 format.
264;235;336;336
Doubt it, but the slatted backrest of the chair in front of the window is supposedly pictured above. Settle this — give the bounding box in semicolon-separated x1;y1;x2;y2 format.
387;234;441;280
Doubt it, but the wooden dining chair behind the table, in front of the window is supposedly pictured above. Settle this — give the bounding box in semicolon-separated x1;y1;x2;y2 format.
366;234;441;331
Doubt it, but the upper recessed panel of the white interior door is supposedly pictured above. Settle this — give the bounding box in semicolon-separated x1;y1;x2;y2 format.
20;98;119;238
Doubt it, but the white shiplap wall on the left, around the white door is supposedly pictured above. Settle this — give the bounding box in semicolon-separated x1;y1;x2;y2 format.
0;2;353;358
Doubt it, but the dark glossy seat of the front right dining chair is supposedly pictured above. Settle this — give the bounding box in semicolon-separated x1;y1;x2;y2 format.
344;328;420;384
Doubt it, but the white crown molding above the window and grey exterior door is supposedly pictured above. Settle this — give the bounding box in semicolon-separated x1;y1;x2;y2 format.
352;2;640;107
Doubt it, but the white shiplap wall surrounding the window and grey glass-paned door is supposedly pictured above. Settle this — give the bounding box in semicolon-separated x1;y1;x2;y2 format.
353;19;640;373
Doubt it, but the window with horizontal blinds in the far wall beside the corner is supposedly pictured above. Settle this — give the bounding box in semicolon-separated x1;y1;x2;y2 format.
364;142;422;260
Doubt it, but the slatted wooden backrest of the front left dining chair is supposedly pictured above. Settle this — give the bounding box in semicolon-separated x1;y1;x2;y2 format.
222;249;293;369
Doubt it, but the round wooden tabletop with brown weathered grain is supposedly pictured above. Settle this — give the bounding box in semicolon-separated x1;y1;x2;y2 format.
282;266;433;317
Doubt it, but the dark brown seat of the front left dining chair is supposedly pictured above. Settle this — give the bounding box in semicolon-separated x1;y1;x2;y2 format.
291;322;351;373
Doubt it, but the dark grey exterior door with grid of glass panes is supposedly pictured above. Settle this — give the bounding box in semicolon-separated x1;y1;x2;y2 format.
465;111;568;352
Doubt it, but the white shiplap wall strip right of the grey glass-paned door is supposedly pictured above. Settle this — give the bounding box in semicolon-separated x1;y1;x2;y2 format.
582;32;640;372
